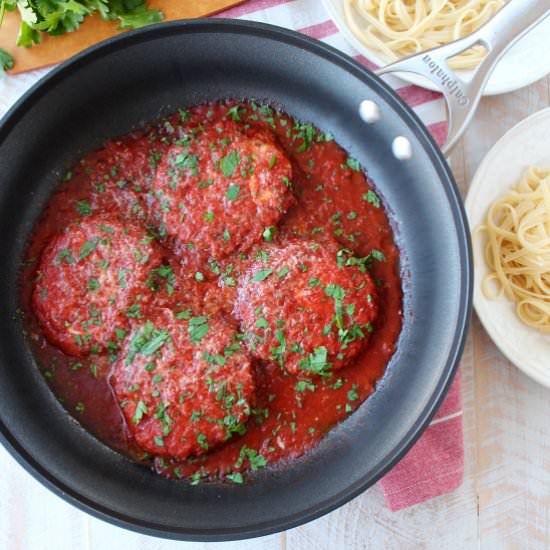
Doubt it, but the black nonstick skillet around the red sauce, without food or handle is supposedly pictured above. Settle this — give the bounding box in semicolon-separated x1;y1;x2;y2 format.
0;20;472;541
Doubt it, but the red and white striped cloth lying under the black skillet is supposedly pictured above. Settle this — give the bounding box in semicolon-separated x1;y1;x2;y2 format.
217;0;464;511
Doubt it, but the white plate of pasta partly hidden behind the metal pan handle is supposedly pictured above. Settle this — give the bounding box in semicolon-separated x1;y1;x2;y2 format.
323;0;550;95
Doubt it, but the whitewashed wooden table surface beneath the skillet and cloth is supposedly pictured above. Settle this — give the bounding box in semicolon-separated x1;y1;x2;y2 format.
0;70;550;550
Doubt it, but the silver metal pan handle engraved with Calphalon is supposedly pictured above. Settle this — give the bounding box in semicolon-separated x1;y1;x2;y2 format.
377;0;550;154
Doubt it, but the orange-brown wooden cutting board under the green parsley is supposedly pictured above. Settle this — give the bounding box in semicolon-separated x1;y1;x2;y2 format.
0;0;243;74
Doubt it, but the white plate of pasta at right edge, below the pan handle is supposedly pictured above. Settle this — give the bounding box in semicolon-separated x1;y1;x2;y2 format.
466;109;550;387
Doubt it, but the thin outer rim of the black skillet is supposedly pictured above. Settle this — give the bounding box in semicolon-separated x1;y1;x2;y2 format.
0;18;473;542
